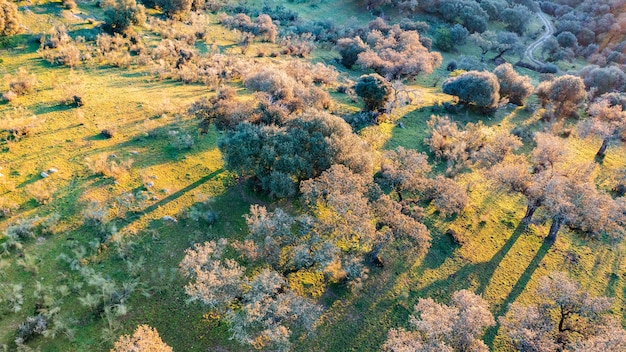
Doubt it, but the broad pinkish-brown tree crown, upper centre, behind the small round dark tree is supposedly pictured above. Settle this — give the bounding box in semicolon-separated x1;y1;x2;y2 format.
357;25;442;79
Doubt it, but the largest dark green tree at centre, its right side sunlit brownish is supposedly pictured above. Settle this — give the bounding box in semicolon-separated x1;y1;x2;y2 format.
218;112;372;197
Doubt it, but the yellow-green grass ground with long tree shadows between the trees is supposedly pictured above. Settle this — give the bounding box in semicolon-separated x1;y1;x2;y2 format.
0;0;626;351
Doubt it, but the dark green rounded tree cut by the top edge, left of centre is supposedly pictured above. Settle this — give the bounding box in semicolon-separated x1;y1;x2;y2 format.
104;0;146;33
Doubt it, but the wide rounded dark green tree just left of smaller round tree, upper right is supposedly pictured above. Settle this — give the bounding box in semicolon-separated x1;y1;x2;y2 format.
441;71;500;109
